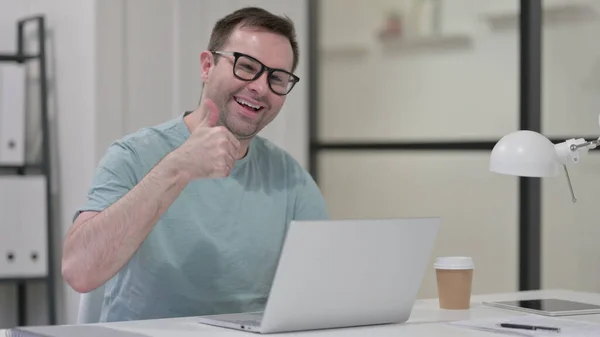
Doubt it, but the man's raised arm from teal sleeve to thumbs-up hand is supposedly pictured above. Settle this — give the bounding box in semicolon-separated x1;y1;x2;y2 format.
62;99;241;292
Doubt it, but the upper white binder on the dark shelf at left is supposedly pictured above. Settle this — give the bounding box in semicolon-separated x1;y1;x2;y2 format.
0;63;27;166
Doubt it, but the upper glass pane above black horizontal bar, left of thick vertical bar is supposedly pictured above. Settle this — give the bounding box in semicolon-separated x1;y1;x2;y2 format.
318;0;519;142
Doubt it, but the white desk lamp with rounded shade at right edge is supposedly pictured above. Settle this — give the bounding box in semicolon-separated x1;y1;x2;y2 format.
490;119;600;202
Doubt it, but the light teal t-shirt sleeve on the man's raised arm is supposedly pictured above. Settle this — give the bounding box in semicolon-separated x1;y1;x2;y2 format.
73;142;139;221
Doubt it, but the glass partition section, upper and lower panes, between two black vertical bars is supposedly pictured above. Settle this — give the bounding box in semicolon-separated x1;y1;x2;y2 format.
312;0;520;297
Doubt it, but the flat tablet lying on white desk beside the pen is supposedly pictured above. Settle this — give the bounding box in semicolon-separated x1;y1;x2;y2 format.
483;298;600;316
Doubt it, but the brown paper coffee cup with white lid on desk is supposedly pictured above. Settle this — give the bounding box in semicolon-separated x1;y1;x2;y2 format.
434;256;475;310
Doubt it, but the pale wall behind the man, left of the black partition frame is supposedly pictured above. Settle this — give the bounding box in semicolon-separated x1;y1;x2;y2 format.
0;0;308;328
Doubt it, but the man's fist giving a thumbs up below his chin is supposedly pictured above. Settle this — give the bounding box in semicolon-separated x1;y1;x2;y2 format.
175;99;240;180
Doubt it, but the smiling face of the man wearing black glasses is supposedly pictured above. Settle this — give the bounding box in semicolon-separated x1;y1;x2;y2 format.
202;27;294;139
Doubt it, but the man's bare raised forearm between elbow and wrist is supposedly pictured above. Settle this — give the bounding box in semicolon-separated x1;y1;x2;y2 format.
63;157;188;292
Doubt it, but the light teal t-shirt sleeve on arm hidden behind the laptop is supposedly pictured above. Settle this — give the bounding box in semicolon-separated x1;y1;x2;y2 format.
294;172;329;220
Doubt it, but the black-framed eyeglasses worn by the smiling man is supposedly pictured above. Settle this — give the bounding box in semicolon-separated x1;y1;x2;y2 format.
212;51;300;96
